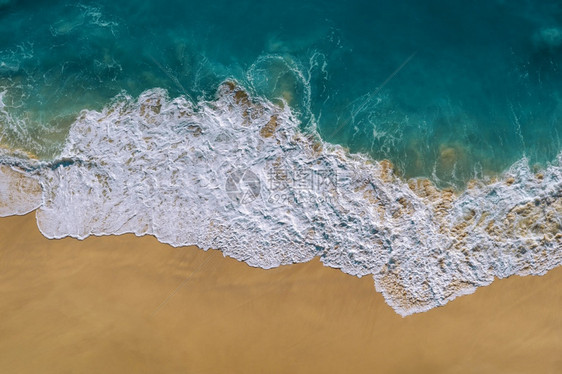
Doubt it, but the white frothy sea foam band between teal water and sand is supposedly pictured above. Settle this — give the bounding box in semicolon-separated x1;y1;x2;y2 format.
0;82;562;315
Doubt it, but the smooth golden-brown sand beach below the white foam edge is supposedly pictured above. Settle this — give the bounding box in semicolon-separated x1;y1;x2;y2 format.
0;214;562;373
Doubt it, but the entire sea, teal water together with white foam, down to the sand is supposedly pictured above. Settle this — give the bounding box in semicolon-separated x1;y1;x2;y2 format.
0;0;562;315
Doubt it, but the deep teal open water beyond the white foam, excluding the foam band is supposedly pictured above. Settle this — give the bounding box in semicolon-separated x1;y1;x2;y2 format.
0;0;562;186
